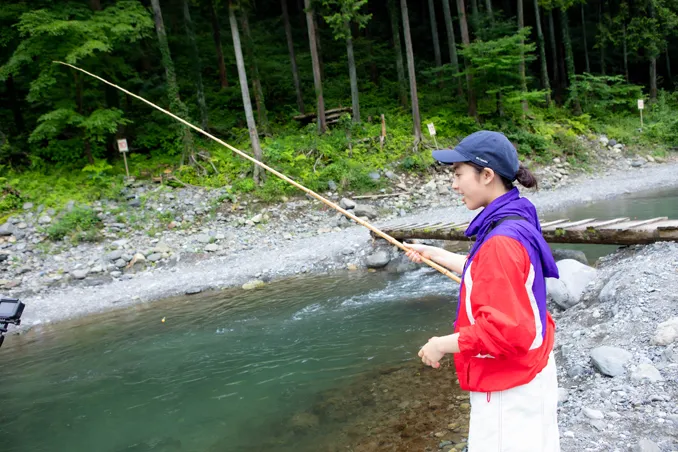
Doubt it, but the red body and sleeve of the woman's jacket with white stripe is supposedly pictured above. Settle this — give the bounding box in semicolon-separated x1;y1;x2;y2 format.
454;235;555;392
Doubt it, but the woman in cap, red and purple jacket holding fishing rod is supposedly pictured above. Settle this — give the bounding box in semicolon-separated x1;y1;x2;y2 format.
407;131;560;452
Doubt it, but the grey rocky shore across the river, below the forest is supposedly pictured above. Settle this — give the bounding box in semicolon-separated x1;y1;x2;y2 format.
0;137;678;327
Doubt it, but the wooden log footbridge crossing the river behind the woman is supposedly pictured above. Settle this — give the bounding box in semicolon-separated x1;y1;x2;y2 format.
372;217;678;245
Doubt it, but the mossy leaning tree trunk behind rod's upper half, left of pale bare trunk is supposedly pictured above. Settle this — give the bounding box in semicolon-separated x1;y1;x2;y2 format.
151;0;193;165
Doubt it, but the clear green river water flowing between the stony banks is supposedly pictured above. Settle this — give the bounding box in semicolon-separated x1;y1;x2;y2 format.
0;185;678;452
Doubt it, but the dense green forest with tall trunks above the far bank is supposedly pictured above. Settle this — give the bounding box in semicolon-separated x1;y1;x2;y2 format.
0;0;678;212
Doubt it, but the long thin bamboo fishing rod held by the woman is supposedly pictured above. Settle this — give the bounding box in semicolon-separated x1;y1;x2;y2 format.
54;61;461;283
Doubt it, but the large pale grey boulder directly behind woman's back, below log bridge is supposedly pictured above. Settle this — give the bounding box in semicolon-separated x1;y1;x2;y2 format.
546;259;598;309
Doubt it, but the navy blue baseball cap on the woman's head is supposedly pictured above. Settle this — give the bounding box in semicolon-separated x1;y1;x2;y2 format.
432;130;520;181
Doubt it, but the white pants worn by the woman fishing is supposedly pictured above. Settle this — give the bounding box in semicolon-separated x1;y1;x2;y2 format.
468;353;560;452
